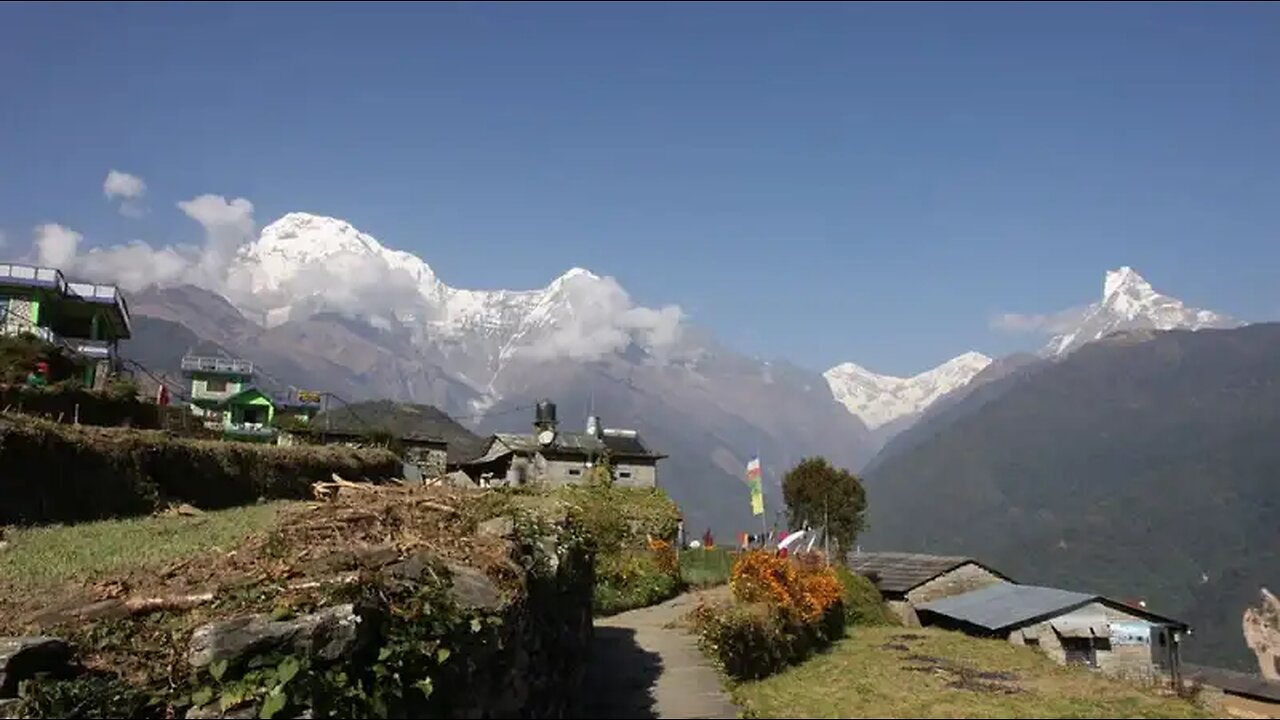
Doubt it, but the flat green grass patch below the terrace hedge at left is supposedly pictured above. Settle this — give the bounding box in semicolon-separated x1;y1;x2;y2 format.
0;502;285;594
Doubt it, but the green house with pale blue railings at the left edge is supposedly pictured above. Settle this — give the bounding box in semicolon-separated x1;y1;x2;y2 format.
0;263;132;387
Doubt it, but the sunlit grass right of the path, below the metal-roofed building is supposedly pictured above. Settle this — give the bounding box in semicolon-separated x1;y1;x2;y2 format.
733;628;1210;717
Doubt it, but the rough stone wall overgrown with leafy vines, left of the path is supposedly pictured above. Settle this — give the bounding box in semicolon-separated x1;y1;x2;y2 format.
0;507;595;717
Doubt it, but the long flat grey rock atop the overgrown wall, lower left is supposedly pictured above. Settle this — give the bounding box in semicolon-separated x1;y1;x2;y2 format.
187;603;361;667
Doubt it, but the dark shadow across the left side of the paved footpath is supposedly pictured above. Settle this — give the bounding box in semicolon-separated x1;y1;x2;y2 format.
573;626;662;720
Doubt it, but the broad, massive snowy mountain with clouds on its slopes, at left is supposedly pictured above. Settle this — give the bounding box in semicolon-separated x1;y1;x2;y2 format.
228;213;681;392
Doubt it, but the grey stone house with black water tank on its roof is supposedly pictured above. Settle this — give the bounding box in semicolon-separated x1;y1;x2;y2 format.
461;400;666;487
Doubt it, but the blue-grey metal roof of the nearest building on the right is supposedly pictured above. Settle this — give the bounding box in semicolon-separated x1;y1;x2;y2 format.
916;583;1100;630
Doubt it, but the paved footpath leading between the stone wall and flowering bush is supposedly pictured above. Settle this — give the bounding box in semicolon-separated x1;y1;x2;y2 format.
581;588;739;719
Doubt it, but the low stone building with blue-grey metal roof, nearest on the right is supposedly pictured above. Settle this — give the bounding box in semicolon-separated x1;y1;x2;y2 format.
916;583;1189;678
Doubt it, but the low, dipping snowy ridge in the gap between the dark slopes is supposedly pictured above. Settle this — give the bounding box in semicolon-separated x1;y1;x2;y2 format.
823;352;991;429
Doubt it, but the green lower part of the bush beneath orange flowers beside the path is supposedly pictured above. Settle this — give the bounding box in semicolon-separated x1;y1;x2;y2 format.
694;603;845;680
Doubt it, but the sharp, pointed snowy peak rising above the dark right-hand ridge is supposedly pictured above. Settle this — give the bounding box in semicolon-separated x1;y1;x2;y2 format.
1041;266;1240;357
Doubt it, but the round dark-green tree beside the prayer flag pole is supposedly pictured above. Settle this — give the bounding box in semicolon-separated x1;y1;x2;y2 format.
782;457;867;557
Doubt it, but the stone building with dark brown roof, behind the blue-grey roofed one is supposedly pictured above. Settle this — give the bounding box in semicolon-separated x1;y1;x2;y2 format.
849;552;1009;628
